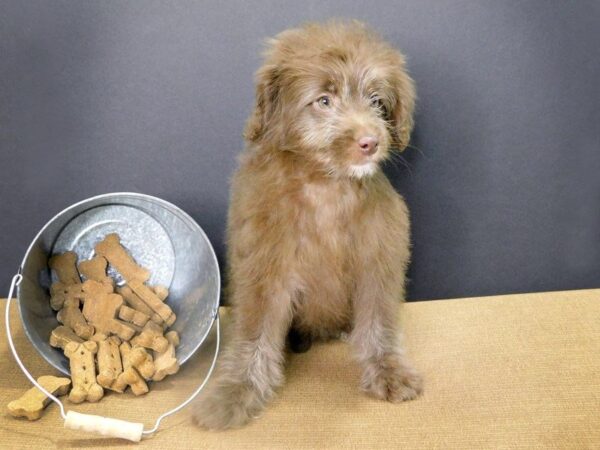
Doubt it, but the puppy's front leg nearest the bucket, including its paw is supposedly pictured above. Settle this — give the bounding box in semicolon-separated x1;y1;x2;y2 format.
194;287;292;430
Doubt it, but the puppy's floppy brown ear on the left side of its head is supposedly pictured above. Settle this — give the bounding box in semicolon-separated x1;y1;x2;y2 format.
244;64;280;142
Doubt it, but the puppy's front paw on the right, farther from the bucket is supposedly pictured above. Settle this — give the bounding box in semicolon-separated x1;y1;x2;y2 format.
361;356;423;403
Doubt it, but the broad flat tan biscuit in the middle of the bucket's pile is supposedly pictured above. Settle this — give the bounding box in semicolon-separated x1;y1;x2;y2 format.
83;280;135;341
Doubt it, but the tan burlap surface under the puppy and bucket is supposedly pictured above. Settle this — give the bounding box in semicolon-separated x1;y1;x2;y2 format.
0;290;600;450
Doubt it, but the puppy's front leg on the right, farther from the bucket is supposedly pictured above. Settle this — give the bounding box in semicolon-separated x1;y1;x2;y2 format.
350;261;422;402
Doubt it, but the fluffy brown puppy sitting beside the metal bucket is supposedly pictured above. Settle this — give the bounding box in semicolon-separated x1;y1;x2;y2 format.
195;21;421;429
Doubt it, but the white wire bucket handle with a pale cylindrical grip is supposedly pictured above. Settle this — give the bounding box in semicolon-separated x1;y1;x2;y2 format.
4;273;221;442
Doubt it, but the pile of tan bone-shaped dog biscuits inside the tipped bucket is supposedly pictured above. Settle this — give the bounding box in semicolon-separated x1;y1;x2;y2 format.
49;233;179;403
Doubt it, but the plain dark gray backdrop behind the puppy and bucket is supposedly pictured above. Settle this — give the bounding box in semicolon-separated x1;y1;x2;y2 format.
0;0;600;299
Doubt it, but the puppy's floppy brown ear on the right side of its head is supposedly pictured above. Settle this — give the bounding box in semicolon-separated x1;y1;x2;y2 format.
389;59;416;151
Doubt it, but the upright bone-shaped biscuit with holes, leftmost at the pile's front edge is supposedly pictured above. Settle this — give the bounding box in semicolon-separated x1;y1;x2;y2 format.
65;341;104;403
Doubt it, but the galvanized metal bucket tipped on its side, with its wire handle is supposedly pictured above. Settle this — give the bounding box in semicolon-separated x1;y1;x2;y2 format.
5;192;221;440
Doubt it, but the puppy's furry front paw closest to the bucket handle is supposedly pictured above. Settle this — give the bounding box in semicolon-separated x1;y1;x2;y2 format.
193;385;263;430
